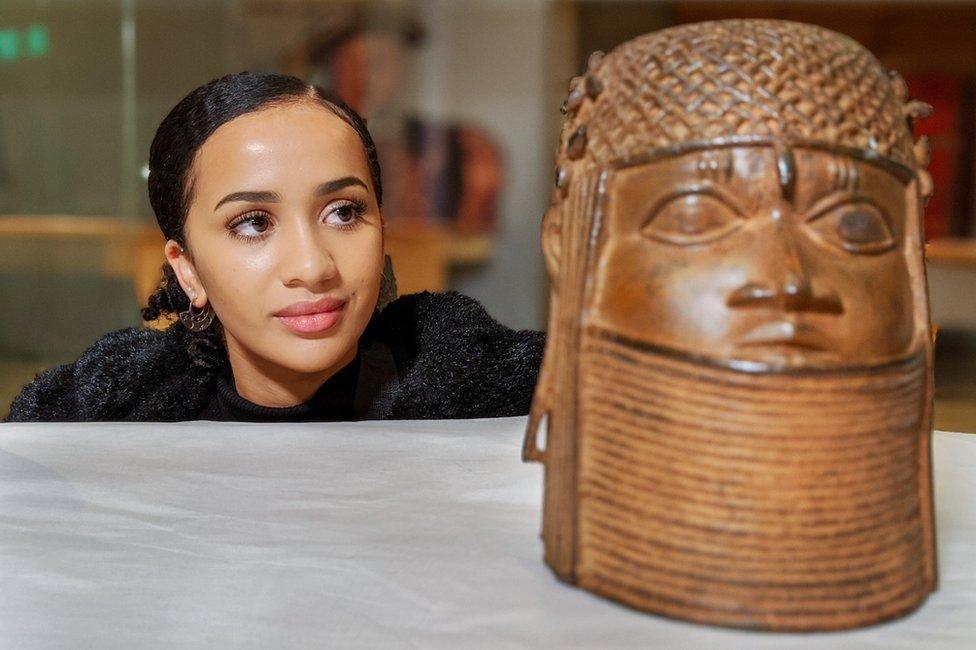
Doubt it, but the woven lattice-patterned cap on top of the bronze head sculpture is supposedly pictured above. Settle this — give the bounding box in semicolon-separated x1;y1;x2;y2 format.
563;20;918;169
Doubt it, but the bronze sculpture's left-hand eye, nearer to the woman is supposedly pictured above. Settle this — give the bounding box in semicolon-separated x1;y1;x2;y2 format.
641;192;741;246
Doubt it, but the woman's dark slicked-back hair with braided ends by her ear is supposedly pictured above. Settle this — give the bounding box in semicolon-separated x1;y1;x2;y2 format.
142;72;383;367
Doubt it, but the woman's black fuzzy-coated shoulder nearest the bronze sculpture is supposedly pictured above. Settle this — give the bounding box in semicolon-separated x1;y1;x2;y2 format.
374;291;546;419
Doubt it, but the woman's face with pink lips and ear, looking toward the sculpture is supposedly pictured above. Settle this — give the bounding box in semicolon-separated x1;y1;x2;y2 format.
166;102;383;375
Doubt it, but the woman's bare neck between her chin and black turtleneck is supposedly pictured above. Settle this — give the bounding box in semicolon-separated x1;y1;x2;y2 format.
221;339;357;408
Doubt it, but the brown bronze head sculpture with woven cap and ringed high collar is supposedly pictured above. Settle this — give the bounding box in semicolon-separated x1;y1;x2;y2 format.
523;20;936;630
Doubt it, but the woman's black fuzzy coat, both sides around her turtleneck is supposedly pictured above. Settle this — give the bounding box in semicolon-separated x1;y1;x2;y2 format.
5;291;545;422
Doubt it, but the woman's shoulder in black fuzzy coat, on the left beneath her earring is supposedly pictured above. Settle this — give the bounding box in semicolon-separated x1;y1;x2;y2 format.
6;323;210;422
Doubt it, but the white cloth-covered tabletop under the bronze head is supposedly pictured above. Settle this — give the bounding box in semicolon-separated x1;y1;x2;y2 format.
0;418;976;650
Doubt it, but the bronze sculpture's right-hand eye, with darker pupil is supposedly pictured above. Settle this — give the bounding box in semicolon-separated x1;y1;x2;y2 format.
810;201;895;254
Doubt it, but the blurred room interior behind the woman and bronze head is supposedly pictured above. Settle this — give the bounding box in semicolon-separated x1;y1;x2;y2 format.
0;0;976;431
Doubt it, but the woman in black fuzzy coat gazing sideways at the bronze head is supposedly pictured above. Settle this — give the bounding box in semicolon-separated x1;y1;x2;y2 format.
7;72;544;422
